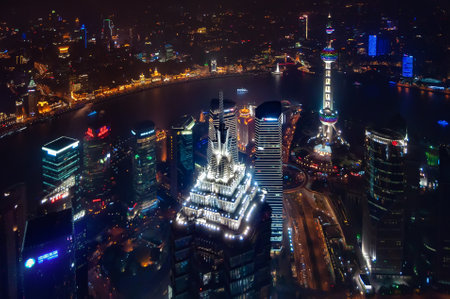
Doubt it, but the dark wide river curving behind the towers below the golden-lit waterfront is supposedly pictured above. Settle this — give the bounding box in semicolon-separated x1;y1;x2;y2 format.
0;73;450;198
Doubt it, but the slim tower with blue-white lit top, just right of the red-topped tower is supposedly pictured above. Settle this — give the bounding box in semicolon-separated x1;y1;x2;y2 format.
131;121;156;211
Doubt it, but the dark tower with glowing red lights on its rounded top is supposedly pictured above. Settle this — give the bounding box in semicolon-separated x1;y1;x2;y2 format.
81;112;112;213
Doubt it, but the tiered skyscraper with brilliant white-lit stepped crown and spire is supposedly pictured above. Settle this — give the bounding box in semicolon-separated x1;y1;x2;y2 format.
171;97;271;298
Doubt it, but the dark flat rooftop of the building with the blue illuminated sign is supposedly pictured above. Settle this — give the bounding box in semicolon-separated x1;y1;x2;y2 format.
24;209;72;248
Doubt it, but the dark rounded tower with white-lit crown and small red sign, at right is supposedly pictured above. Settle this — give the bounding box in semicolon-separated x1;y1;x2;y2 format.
363;129;408;275
